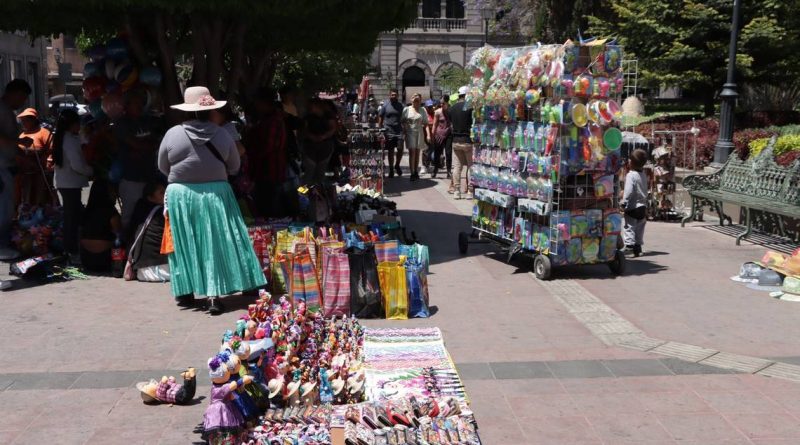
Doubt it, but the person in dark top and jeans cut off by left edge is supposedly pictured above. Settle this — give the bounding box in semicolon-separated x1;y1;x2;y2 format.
0;79;33;260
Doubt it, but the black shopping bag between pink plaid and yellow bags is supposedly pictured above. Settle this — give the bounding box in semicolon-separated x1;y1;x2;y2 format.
347;246;383;318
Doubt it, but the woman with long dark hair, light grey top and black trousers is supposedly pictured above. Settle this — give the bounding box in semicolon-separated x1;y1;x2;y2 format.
53;109;93;265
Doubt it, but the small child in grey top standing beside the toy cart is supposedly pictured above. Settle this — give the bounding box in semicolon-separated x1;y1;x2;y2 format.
620;149;648;257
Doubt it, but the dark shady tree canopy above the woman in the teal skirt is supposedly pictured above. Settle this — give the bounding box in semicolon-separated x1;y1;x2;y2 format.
0;0;417;114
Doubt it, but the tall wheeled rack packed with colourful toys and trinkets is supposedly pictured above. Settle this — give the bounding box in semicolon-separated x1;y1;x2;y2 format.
459;41;624;279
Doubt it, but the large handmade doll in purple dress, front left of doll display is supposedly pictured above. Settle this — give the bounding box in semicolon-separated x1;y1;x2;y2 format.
203;356;251;445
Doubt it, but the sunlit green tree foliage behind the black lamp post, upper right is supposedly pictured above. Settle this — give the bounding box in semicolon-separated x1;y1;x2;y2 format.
590;0;800;115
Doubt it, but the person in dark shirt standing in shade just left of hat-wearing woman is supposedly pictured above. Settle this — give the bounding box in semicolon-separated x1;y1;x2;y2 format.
113;90;161;229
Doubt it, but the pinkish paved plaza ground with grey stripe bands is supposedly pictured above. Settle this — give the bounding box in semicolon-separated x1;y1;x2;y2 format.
0;172;800;445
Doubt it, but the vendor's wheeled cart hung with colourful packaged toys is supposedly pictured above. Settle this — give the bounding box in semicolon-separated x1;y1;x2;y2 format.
458;45;625;280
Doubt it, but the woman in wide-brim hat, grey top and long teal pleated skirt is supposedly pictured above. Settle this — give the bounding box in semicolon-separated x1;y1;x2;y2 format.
158;87;266;315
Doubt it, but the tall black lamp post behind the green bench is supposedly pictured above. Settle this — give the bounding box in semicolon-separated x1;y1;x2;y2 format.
711;0;741;168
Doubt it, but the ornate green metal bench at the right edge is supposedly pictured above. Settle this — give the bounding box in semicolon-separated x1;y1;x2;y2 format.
681;137;800;245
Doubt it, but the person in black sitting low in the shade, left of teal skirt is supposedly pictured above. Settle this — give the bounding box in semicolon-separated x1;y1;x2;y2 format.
80;180;122;272
